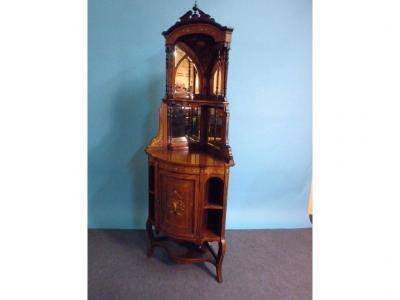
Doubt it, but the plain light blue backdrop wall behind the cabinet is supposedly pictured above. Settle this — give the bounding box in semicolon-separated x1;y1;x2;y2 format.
88;0;312;229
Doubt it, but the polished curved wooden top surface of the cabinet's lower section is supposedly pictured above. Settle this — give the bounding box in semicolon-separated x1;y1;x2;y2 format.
146;149;233;167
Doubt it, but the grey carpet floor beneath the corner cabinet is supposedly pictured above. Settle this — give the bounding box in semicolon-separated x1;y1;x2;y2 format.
88;229;312;300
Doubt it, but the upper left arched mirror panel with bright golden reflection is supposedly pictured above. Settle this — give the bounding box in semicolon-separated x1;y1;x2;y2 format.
174;47;199;99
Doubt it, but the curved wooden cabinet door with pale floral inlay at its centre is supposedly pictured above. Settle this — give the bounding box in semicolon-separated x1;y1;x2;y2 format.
159;170;199;238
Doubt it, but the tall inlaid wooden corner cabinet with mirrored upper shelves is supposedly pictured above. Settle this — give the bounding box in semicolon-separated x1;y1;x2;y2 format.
146;4;234;282
